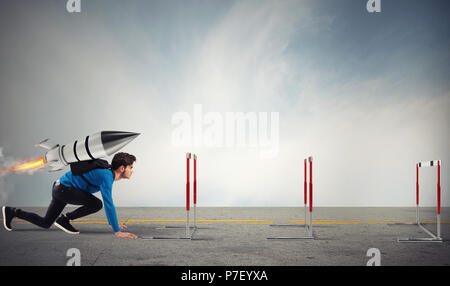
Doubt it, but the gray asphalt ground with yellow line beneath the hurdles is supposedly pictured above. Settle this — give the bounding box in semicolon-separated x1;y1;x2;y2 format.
0;207;450;266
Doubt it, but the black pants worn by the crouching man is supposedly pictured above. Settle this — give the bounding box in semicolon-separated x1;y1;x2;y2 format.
16;181;103;228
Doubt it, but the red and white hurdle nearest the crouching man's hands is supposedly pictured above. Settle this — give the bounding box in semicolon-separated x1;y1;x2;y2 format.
142;153;197;239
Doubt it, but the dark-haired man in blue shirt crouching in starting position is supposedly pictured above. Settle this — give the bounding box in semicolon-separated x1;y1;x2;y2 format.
2;152;137;238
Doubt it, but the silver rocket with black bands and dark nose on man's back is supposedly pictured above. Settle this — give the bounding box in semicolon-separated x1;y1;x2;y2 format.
36;131;140;171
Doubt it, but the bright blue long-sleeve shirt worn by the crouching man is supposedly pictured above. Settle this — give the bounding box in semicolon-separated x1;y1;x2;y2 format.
59;169;120;232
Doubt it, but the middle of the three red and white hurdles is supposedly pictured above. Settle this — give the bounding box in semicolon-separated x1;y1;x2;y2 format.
267;156;314;239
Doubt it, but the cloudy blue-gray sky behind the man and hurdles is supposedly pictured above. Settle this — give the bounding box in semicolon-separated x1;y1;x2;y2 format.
0;0;450;206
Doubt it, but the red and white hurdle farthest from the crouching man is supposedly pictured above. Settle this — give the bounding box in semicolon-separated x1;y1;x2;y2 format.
388;160;443;242
